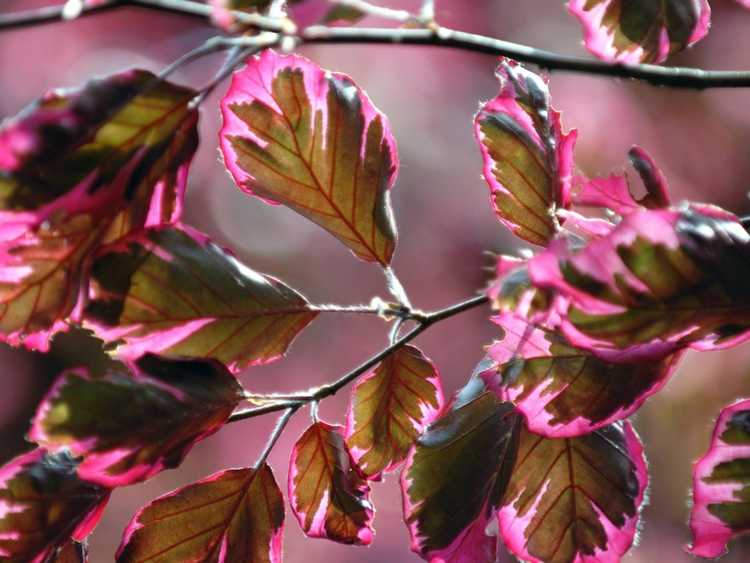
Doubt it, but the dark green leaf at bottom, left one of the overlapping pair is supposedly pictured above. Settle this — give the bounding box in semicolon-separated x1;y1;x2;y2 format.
401;392;520;563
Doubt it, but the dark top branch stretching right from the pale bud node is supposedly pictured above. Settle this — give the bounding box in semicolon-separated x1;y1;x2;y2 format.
301;26;750;89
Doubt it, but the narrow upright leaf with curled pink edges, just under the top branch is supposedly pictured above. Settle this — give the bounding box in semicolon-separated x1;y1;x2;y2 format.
474;59;577;245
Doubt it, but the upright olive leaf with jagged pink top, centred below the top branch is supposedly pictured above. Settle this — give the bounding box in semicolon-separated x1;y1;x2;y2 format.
221;50;398;265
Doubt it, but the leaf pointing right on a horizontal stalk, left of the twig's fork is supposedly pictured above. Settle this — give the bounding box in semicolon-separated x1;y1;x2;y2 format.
84;227;317;372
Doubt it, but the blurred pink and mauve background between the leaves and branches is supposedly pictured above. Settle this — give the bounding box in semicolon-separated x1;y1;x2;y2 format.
0;0;750;563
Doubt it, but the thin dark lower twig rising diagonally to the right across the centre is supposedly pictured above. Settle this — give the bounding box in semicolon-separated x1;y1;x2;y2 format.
228;295;488;422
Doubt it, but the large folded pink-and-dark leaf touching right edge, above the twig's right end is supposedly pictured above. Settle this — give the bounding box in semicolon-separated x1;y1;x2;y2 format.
528;206;750;362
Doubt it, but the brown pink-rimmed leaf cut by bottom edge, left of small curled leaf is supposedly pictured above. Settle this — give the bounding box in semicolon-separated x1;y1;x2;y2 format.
117;464;284;563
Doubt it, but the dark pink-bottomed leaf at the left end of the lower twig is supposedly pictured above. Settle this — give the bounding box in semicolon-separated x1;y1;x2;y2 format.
29;355;243;487
